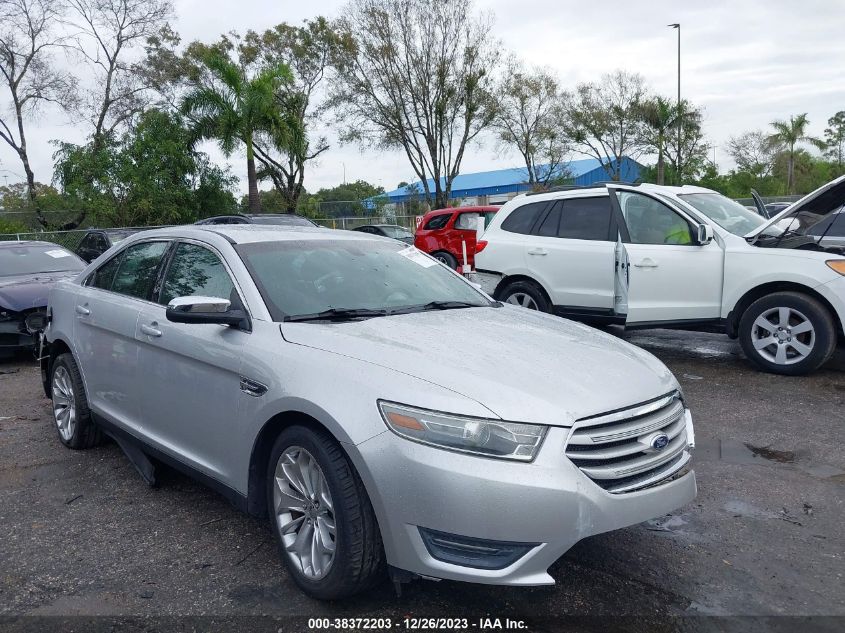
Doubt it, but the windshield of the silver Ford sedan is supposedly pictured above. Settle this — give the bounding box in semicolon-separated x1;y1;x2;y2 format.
236;240;491;321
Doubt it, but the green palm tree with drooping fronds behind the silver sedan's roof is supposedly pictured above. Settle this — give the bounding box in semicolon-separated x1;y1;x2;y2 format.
180;50;291;213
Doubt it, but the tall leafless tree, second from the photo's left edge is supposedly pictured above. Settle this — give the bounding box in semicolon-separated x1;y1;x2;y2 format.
68;0;173;145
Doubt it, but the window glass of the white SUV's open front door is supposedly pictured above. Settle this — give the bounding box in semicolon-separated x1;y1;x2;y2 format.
617;191;692;244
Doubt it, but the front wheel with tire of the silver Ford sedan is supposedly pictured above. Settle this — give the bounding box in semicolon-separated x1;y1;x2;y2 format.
267;426;384;600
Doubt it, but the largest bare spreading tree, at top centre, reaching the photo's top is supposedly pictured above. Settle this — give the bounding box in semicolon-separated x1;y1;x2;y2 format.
331;0;499;206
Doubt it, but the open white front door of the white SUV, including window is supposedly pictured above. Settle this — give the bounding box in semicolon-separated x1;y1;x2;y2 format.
608;185;724;325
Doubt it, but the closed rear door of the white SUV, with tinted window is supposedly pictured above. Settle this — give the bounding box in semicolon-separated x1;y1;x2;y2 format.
525;196;618;315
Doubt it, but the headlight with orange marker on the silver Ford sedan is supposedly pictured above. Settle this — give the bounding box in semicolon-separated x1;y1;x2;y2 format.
378;401;547;462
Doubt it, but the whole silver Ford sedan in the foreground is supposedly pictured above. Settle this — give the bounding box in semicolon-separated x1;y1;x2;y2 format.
43;225;696;599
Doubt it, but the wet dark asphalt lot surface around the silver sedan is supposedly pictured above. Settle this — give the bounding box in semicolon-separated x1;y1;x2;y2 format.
0;330;845;631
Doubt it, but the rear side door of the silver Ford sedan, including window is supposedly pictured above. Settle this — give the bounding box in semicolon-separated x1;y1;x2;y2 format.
74;240;169;429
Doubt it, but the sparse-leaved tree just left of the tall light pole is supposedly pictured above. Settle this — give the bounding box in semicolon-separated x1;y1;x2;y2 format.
565;70;646;180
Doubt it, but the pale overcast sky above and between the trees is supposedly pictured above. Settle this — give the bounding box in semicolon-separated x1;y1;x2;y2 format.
0;0;845;191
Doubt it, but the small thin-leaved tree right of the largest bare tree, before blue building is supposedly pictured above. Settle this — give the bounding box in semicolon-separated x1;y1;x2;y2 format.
493;57;570;187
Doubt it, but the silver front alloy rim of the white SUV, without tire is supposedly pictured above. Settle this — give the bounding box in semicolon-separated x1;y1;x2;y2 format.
751;307;816;365
